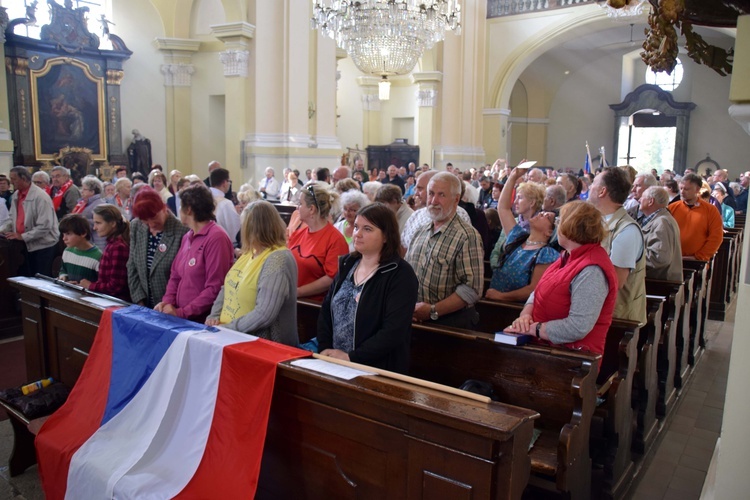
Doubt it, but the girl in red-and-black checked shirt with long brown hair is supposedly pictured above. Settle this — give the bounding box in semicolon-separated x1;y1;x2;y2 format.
79;204;130;302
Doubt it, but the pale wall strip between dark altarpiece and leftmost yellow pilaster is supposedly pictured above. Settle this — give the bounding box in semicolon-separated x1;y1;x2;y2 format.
111;0;171;168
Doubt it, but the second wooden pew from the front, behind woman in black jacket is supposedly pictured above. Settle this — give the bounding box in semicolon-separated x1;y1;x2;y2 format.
297;299;599;498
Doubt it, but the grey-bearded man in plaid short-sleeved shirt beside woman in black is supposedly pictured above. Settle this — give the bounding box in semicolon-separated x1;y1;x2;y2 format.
406;172;484;329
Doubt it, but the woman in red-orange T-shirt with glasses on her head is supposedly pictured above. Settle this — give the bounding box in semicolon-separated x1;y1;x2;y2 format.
287;182;349;301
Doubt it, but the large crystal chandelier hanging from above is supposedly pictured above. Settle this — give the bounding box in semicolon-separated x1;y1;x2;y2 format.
312;0;461;99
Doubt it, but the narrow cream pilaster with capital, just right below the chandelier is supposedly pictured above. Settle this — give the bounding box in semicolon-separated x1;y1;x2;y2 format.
411;71;443;167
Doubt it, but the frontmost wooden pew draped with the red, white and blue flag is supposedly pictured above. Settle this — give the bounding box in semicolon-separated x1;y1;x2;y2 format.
13;282;539;500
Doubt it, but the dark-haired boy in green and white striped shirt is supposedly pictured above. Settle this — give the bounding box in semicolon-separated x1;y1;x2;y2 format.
59;214;102;282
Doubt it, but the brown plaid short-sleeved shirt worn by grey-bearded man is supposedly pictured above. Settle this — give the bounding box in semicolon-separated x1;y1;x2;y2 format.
406;214;484;305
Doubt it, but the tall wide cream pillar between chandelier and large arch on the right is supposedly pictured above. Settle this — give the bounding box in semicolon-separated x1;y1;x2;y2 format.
432;2;487;170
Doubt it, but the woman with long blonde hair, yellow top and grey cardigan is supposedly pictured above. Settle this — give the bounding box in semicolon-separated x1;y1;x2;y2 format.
206;200;299;346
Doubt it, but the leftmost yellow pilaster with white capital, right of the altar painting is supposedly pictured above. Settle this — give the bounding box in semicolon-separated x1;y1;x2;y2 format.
154;38;201;175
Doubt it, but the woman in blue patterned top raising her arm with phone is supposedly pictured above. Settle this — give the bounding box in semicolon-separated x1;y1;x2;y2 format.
485;168;560;302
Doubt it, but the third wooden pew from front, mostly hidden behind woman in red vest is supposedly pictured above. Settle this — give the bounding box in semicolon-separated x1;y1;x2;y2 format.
476;300;639;498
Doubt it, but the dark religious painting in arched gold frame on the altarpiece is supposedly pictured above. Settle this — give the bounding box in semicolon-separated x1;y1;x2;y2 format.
30;57;107;161
